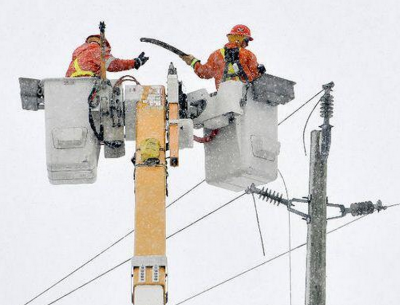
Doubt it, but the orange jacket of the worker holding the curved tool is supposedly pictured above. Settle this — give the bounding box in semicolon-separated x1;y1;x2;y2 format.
193;43;259;89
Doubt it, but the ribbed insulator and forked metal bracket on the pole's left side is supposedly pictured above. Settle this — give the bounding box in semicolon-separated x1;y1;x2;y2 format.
245;183;310;223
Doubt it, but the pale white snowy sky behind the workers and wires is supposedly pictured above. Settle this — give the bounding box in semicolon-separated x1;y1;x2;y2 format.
0;0;400;305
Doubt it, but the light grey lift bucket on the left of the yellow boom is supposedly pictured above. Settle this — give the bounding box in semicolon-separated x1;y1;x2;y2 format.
43;77;100;184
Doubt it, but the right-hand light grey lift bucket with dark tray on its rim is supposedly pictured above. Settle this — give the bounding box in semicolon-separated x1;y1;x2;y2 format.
202;76;295;191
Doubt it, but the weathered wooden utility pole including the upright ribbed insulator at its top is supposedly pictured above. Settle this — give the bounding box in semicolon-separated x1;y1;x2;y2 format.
305;82;335;305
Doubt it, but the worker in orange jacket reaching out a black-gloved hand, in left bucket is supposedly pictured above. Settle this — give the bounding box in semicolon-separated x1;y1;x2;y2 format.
66;35;149;77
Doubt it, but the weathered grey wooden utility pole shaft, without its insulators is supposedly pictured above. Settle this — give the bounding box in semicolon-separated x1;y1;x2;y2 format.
305;130;327;305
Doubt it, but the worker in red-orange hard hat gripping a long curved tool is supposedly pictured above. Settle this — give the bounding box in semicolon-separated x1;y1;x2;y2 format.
181;24;265;89
